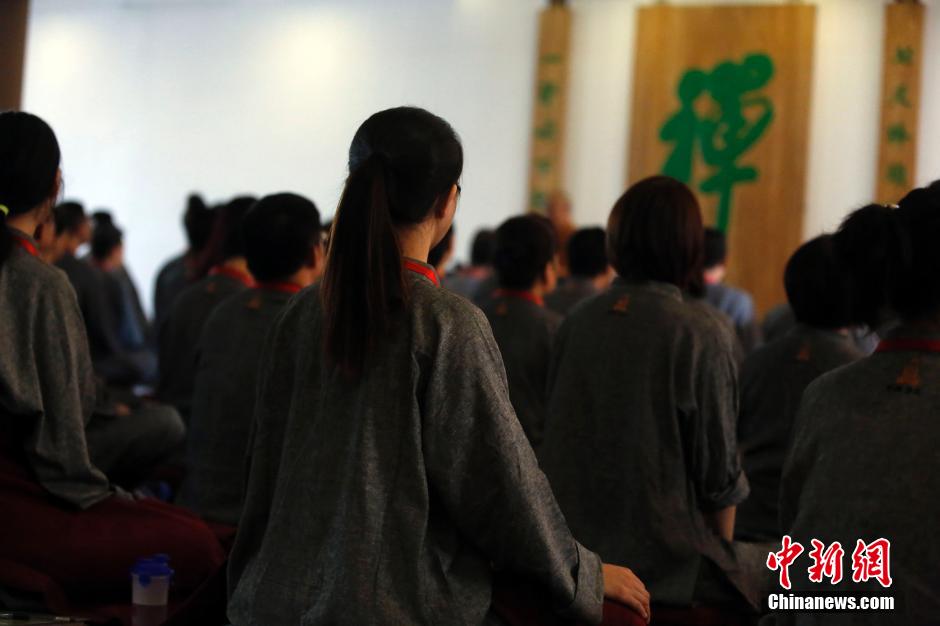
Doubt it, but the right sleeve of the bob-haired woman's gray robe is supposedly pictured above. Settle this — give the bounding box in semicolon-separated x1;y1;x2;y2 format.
686;330;750;512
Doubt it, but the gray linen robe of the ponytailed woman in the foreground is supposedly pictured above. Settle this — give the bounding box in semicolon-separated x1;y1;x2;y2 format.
228;264;603;626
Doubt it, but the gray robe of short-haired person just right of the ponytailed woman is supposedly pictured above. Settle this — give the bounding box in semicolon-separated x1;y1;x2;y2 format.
483;296;562;448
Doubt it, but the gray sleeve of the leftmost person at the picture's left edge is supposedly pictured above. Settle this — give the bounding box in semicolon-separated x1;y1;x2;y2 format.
26;277;111;508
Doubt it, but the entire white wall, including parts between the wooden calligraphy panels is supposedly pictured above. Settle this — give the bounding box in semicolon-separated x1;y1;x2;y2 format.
24;0;940;312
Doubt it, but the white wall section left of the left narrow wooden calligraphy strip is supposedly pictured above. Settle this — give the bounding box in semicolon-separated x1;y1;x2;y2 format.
23;0;540;310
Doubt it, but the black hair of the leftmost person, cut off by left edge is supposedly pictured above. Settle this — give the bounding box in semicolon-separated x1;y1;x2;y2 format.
0;111;62;267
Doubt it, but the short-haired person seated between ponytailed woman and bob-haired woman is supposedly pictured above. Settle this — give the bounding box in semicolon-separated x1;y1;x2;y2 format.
483;215;561;448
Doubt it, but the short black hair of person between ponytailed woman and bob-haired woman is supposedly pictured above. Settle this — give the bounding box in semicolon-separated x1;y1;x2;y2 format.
493;215;556;289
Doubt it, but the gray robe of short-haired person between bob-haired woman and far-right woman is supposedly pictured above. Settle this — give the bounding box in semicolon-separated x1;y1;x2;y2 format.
735;324;864;541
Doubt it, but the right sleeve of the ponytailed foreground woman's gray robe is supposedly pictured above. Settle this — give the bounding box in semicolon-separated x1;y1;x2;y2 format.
423;315;603;623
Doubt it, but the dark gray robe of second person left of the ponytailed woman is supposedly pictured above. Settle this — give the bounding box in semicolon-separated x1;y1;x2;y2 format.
157;274;248;421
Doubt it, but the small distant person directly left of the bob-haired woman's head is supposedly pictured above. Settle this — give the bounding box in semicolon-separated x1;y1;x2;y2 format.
545;227;614;316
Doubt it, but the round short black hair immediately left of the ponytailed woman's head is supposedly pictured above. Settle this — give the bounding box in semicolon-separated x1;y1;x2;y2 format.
242;193;320;281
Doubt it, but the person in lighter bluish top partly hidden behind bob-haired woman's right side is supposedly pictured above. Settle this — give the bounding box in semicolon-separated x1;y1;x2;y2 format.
704;228;761;355
